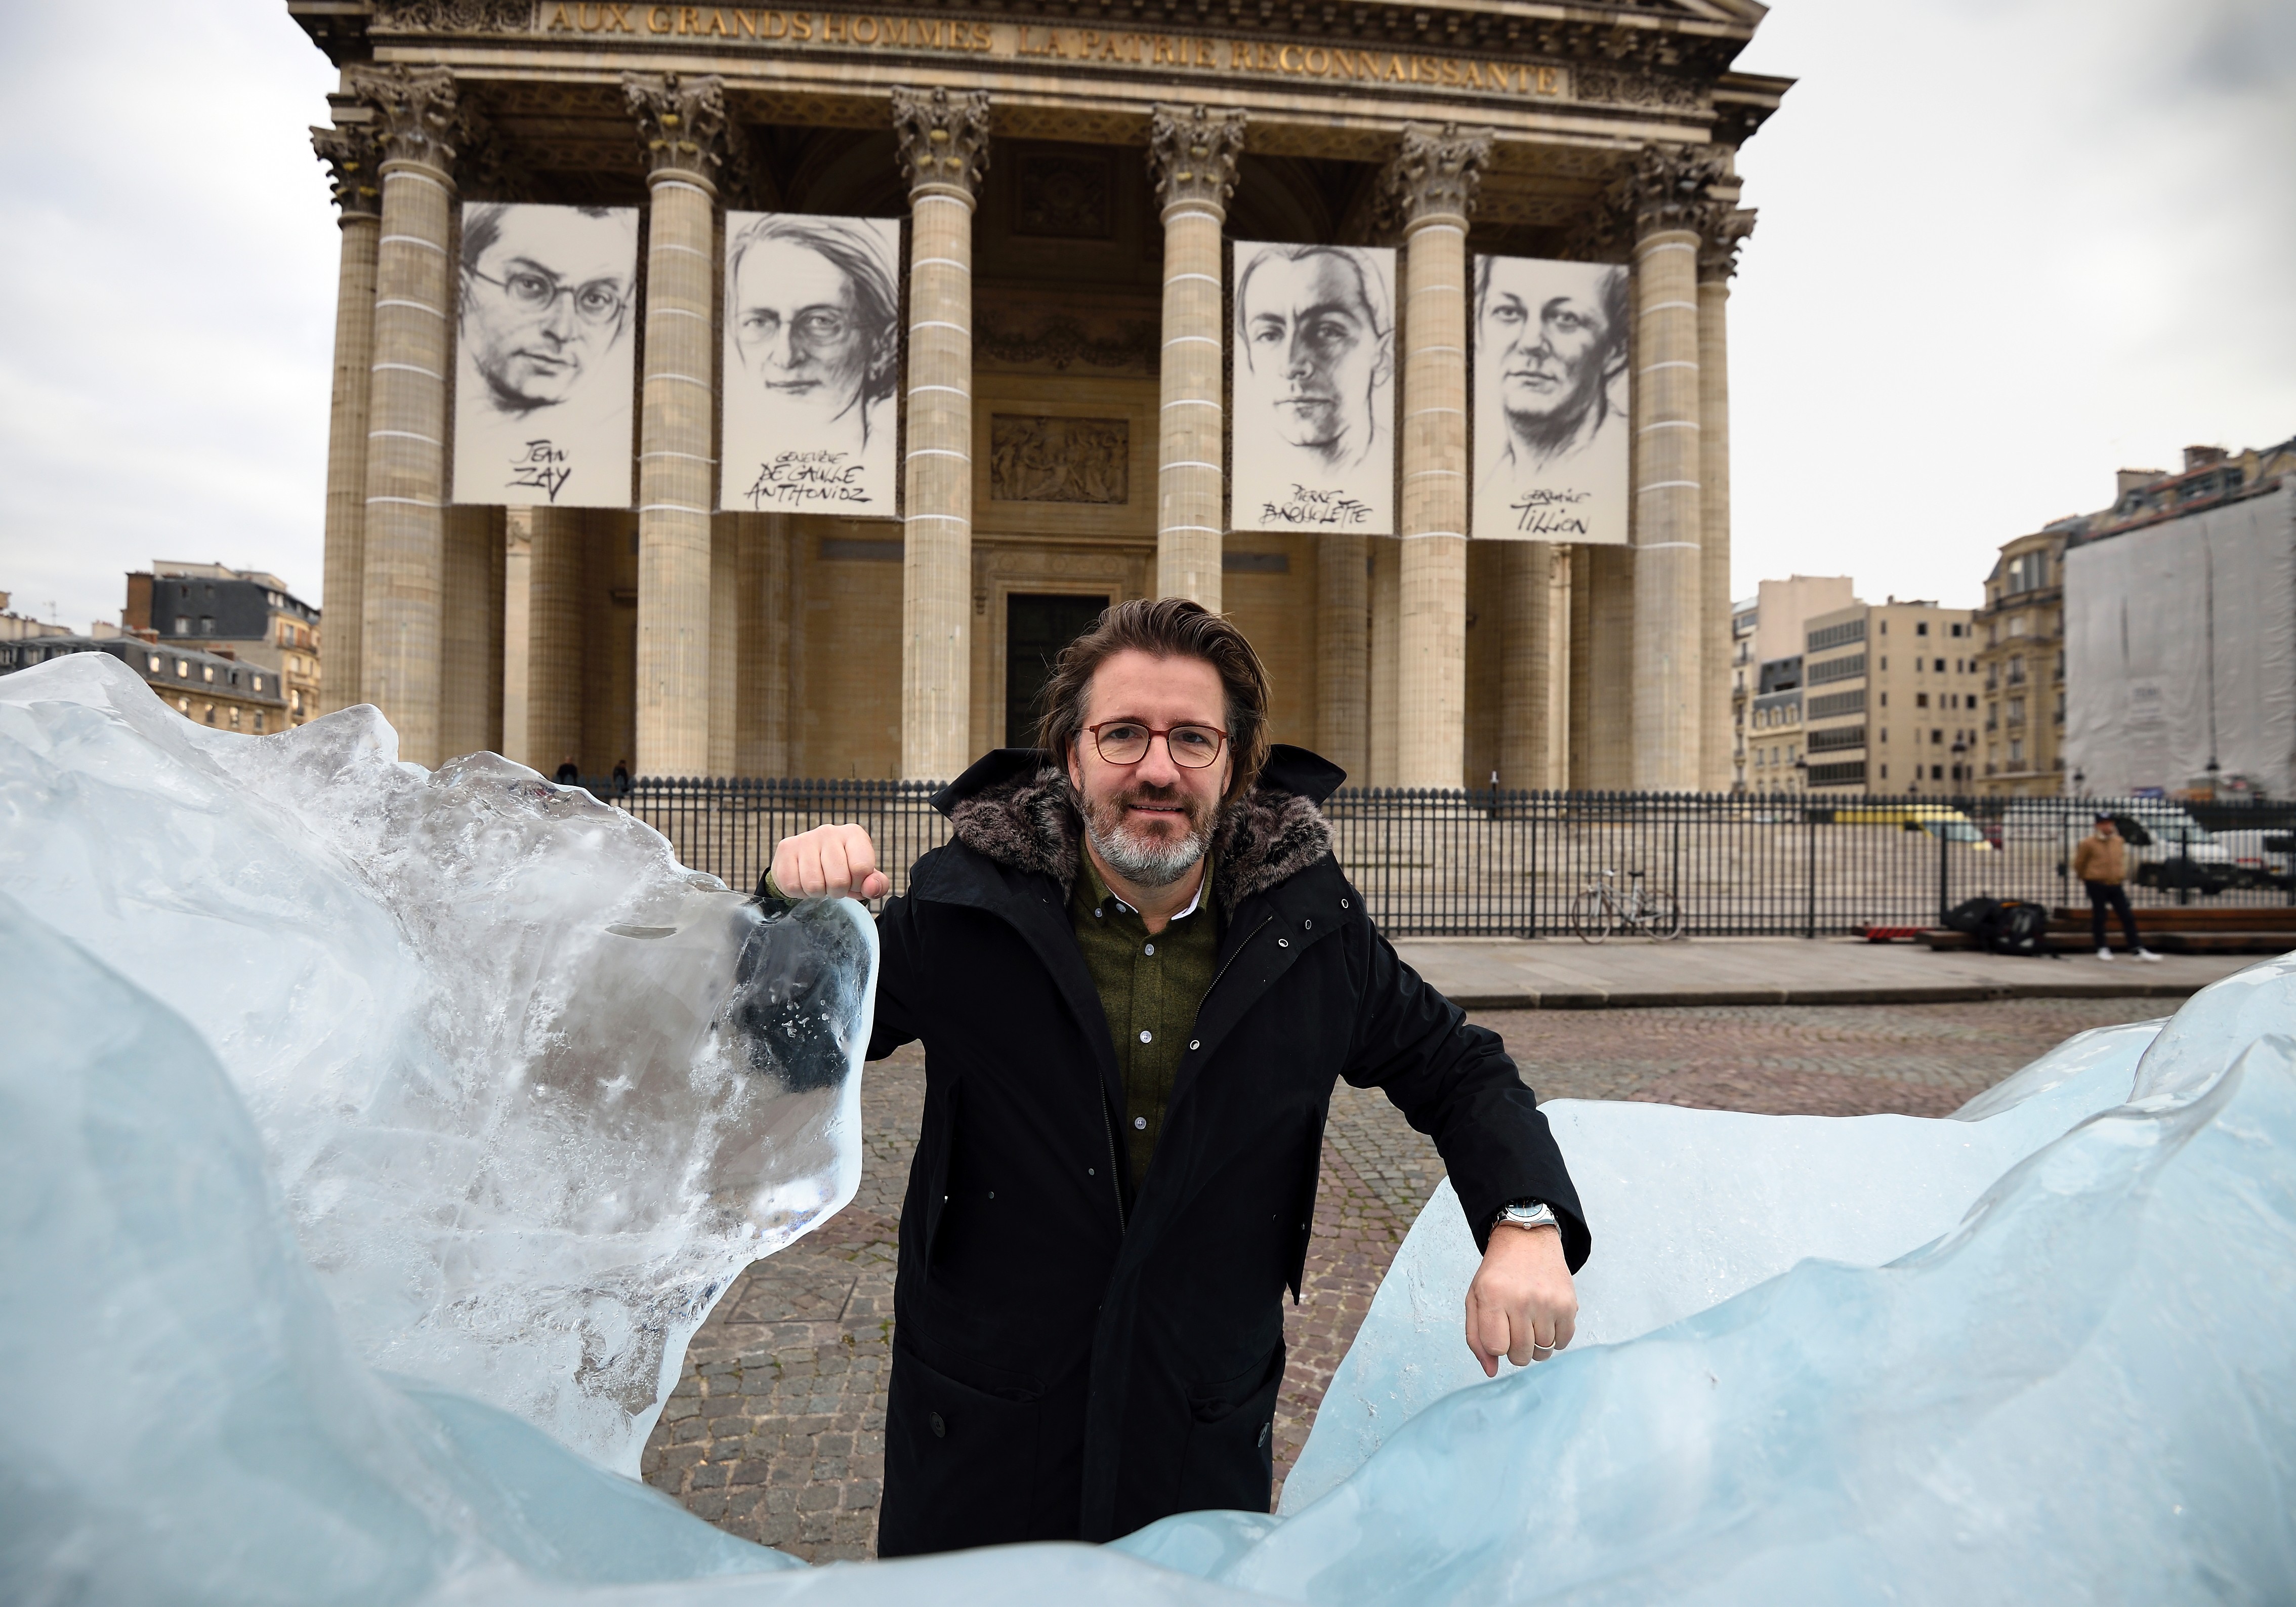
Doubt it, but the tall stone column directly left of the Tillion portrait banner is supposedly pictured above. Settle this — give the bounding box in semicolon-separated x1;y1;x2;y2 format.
1382;124;1492;788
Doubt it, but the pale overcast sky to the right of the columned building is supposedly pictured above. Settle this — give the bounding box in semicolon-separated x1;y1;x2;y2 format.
1731;0;2296;604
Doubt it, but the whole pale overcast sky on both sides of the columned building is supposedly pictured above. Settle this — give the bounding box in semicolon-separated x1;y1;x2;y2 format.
0;0;2296;629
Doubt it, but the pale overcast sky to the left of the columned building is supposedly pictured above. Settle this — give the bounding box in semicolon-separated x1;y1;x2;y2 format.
0;0;338;629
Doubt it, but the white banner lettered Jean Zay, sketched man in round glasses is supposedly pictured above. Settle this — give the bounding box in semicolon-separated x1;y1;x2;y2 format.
454;202;638;507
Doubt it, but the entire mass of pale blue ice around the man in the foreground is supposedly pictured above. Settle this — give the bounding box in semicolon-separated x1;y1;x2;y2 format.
0;656;2296;1607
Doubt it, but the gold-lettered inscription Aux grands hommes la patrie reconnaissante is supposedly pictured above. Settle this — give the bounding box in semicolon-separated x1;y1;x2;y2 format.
537;5;1568;99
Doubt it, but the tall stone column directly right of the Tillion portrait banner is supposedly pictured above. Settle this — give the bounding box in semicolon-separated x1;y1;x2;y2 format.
1628;145;1722;792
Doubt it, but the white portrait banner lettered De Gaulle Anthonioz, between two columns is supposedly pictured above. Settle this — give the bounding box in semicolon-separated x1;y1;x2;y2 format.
719;211;900;519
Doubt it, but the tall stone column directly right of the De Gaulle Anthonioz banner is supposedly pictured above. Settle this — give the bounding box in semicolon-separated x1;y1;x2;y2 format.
893;90;989;780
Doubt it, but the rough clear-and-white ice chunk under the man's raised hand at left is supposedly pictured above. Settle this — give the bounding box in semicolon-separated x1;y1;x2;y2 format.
0;654;877;1474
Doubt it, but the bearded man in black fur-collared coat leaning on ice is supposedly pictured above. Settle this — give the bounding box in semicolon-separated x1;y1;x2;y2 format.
760;597;1589;1556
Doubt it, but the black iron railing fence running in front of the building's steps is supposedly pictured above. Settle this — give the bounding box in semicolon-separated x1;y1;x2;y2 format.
593;778;2296;937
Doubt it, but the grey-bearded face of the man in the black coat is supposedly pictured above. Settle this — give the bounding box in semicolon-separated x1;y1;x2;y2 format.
1068;650;1233;886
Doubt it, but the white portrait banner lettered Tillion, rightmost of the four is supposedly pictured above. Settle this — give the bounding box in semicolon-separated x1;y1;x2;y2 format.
1470;257;1633;547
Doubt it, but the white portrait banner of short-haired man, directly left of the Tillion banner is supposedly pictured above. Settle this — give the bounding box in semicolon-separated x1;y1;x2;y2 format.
1228;241;1396;535
